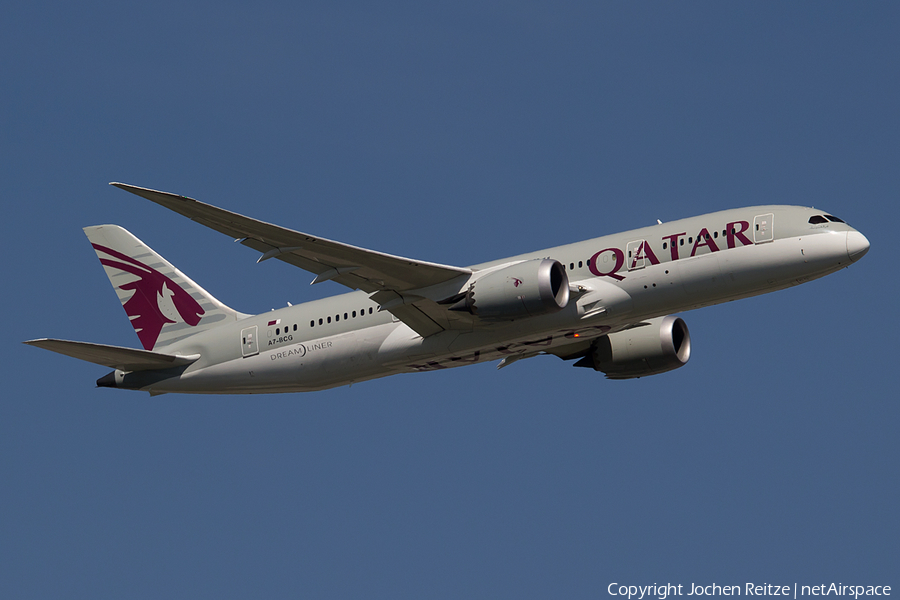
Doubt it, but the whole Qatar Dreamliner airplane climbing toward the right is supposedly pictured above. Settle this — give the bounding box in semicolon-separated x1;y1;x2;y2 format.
24;182;869;395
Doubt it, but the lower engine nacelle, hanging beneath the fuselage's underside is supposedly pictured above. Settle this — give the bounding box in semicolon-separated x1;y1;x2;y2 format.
578;315;691;379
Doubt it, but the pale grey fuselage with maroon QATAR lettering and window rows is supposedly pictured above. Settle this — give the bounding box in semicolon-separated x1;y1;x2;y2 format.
123;206;868;393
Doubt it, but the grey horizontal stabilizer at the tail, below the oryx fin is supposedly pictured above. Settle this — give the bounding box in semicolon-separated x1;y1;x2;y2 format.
23;338;200;371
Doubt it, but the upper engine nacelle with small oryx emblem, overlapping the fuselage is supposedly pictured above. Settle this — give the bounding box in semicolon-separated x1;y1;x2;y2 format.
451;258;569;320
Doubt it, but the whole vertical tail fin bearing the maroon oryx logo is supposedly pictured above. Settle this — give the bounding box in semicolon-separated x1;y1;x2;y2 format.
84;225;247;350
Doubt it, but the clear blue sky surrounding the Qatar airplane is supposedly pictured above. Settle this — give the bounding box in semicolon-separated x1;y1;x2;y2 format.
0;2;900;598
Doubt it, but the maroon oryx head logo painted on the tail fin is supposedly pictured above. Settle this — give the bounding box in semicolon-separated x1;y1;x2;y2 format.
92;244;205;350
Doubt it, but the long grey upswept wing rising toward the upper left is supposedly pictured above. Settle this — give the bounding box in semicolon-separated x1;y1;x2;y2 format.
110;182;472;337
